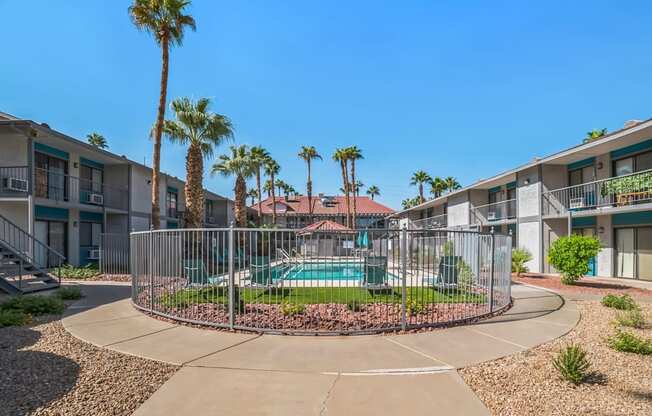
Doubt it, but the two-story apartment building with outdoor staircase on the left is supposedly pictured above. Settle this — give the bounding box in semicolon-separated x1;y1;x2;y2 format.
0;113;234;268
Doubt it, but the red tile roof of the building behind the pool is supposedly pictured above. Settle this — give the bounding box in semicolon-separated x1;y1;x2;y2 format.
251;196;394;217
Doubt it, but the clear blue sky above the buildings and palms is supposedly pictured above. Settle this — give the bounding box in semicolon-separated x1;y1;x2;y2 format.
0;0;652;208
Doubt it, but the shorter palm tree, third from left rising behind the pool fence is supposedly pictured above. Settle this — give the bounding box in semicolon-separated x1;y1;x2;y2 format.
211;144;255;227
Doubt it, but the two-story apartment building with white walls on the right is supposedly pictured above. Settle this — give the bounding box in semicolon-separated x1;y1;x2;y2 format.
390;120;652;280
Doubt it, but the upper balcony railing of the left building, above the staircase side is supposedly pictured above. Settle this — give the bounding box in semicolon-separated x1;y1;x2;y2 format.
34;168;129;210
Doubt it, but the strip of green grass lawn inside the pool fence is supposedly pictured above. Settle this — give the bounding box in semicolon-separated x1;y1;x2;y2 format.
161;287;485;307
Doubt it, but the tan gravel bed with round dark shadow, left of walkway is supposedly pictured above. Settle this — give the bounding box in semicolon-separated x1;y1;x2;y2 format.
0;319;177;416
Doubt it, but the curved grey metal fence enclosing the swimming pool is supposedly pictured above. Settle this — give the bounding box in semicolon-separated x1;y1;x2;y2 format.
130;228;511;334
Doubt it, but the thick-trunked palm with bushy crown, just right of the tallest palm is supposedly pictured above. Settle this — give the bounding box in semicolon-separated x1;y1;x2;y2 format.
163;98;233;228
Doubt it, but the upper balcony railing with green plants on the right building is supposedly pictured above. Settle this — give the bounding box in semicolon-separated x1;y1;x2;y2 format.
543;169;652;215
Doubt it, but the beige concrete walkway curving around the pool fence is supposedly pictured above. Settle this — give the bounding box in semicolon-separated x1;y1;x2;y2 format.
63;283;579;415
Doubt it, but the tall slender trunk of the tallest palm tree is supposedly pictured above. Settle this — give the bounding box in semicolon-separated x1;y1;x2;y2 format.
152;36;170;230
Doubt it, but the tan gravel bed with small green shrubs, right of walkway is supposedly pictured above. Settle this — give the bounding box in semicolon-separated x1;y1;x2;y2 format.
460;301;652;415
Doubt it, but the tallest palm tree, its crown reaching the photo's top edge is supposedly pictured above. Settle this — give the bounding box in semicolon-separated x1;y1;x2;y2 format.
128;0;196;229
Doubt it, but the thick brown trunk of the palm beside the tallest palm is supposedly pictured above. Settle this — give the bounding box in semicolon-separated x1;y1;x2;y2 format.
185;143;204;228
